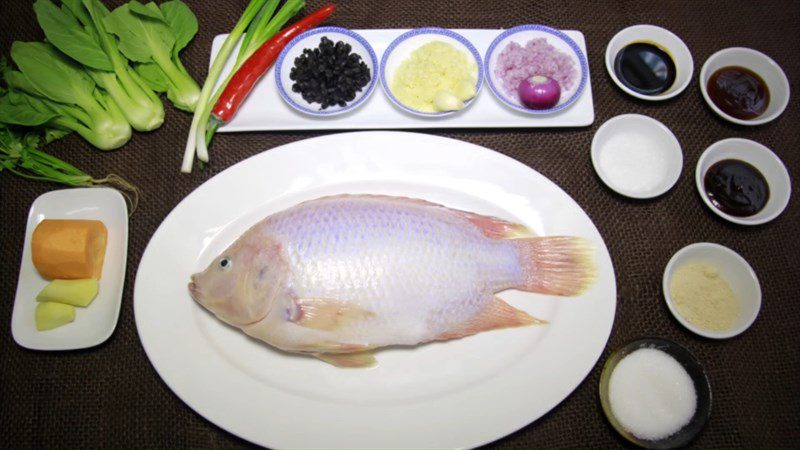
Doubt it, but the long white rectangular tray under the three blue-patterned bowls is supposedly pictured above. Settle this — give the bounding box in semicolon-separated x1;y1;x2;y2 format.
211;29;594;133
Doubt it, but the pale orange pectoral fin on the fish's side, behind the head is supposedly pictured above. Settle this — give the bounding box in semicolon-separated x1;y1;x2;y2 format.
289;298;375;331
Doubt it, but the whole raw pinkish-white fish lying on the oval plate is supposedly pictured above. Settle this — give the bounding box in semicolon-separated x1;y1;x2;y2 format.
189;195;594;366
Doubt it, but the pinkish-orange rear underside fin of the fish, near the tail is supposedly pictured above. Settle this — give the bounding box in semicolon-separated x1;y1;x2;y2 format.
434;297;547;341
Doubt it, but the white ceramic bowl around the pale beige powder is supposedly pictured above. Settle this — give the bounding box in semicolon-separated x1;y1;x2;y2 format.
662;242;761;339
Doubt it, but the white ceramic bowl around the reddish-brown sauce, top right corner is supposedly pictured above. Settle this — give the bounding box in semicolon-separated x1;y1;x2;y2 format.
698;47;789;125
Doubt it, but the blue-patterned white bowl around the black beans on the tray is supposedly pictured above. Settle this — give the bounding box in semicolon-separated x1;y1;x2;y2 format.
275;27;378;117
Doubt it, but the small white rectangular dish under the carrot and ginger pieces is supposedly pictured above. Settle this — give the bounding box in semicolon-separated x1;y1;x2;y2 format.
11;188;128;350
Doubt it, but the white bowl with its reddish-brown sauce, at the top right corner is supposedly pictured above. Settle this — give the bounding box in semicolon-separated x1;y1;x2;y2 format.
699;47;789;126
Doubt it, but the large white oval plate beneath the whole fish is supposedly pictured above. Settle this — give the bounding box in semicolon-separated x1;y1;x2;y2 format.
134;132;616;448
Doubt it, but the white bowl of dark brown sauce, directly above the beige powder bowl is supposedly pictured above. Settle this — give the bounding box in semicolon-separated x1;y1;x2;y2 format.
695;138;792;225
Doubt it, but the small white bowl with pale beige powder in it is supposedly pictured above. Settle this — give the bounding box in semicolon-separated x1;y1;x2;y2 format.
662;242;761;339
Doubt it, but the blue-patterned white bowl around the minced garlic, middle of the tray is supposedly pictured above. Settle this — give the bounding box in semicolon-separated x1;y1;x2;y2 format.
380;28;483;117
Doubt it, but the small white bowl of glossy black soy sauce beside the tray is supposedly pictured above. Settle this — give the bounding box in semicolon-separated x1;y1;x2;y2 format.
605;25;694;101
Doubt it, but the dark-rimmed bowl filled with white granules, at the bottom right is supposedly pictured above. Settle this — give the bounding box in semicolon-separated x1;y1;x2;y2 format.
600;338;711;449
